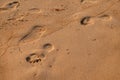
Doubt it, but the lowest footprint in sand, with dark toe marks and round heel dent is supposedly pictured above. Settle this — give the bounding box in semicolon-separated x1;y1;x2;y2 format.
26;43;54;64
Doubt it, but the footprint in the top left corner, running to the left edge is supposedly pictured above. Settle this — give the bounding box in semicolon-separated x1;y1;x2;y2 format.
0;1;20;12
